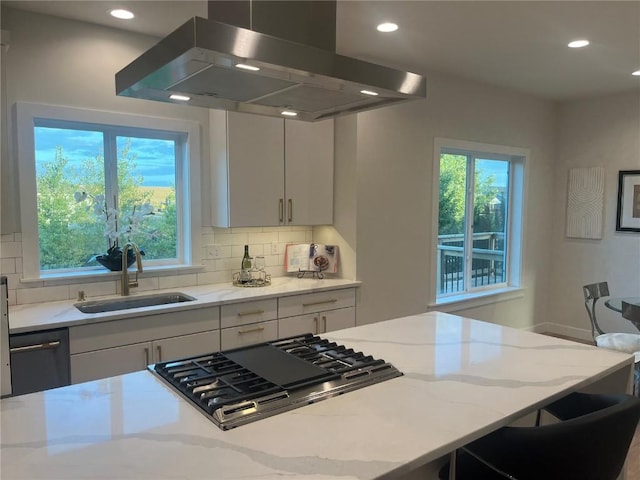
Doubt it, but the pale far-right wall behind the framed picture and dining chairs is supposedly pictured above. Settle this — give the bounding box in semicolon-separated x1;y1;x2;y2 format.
548;92;640;339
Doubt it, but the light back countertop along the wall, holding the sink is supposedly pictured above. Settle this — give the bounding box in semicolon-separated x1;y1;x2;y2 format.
9;277;361;333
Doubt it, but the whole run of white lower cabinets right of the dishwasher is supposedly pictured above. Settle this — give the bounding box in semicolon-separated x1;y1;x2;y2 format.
69;288;356;383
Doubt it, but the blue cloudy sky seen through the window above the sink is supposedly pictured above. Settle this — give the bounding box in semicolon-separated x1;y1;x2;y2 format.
35;127;175;187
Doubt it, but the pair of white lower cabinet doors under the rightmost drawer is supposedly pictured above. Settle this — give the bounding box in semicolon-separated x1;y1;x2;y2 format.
278;307;356;338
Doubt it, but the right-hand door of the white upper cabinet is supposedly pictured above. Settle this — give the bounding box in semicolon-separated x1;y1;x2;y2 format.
284;120;334;225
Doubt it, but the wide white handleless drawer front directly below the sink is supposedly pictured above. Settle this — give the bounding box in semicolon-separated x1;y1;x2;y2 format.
69;307;220;354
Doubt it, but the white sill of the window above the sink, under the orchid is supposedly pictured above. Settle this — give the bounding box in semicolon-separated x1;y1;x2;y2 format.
20;265;204;285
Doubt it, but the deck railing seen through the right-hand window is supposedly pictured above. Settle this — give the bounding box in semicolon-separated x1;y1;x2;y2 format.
437;232;506;294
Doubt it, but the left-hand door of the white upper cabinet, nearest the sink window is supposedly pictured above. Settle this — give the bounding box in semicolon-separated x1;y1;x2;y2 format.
227;112;284;227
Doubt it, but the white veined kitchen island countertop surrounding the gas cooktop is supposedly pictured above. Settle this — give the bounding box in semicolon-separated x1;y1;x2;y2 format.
0;312;632;480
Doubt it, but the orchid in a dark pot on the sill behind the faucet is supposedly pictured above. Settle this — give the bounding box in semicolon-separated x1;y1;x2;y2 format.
74;192;154;272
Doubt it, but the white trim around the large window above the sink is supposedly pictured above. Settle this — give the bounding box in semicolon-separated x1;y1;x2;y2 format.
16;102;202;281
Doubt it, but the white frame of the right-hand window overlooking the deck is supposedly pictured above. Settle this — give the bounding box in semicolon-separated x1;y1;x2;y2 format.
429;138;530;308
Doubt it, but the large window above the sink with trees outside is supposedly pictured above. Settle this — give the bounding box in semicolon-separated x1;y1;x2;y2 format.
18;104;199;278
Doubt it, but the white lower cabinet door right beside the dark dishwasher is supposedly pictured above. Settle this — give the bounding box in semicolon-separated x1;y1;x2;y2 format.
71;342;152;384
